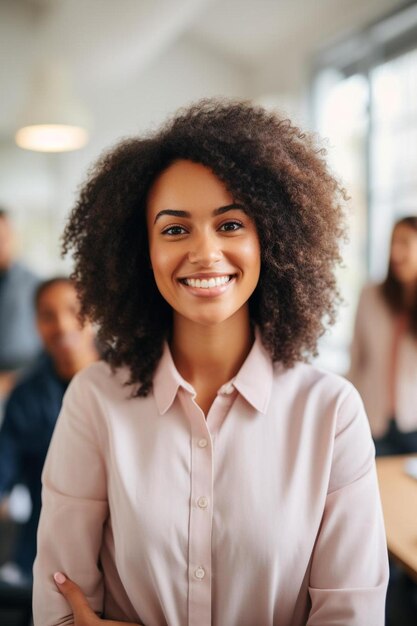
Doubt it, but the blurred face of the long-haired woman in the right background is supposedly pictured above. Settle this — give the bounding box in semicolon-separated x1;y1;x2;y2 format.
390;224;417;283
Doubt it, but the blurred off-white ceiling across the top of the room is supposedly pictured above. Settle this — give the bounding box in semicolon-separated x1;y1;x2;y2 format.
0;0;407;137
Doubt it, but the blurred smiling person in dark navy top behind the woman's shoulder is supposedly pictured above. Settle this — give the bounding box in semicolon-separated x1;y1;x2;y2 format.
0;277;98;583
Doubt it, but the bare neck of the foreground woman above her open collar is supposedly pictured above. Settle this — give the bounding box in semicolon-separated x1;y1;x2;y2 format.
171;309;254;413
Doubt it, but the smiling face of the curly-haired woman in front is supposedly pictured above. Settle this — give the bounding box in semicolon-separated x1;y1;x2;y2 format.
147;160;261;325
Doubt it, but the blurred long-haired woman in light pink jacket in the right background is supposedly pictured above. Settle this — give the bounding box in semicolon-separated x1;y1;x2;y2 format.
348;216;417;455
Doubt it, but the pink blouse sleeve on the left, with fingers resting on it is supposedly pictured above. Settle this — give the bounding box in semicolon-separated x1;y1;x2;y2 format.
33;372;108;626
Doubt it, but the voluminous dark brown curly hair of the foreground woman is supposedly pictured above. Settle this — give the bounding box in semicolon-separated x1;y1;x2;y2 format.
63;100;345;396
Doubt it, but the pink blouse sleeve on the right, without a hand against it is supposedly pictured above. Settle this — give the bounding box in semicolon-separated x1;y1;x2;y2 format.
307;390;388;626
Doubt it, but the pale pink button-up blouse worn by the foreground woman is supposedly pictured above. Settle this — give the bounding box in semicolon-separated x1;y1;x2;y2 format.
34;339;388;626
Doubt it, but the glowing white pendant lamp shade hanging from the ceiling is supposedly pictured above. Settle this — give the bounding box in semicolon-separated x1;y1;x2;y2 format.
15;63;90;152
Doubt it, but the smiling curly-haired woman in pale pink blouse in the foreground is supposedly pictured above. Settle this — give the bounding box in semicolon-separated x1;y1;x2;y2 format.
34;100;388;626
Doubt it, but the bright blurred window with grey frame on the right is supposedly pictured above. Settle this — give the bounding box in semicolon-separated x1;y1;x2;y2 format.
312;5;417;373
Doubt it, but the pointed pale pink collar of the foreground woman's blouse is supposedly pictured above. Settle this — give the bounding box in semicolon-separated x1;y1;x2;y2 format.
153;330;273;415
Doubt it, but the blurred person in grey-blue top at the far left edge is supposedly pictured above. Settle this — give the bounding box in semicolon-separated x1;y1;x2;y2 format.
0;208;40;402
